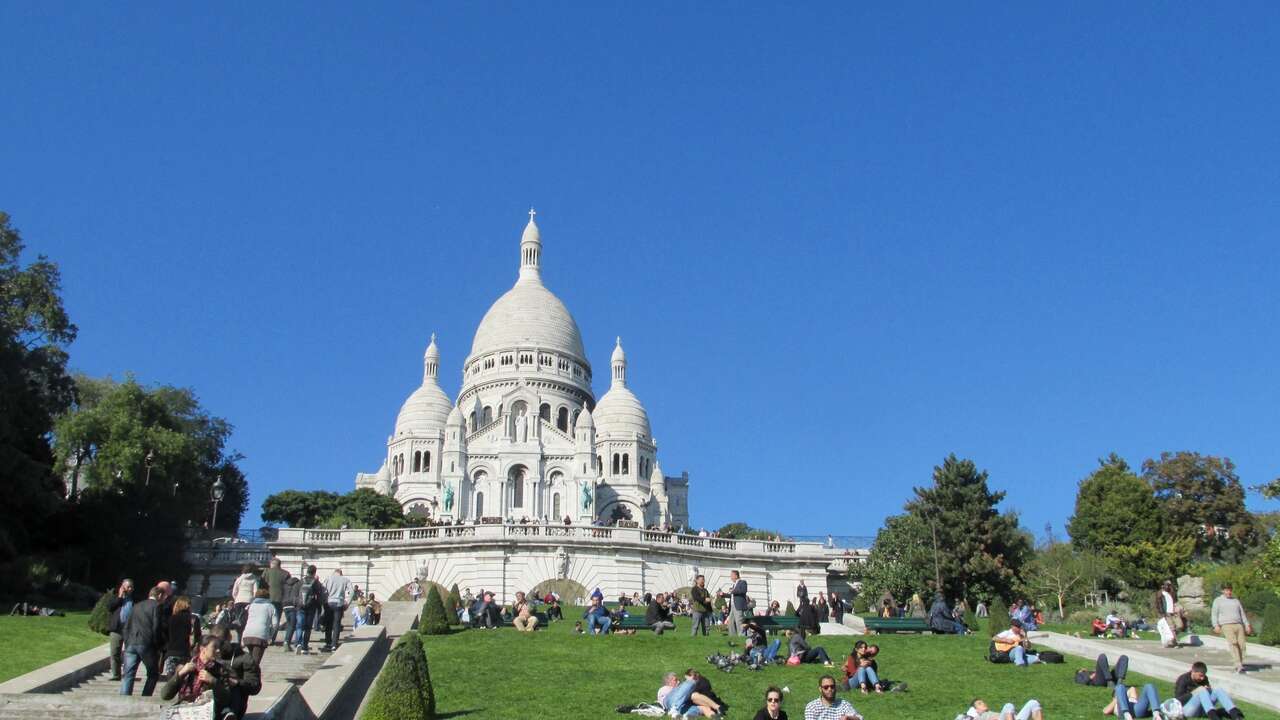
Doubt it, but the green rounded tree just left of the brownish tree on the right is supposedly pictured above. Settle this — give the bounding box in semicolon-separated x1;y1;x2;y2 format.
1066;452;1164;552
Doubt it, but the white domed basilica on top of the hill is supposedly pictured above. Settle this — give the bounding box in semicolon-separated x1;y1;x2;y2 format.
356;210;689;528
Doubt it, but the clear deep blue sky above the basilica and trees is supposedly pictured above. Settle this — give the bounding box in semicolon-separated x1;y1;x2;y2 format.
0;3;1280;534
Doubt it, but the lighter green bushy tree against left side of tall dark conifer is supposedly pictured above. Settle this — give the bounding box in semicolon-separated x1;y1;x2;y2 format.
849;514;934;598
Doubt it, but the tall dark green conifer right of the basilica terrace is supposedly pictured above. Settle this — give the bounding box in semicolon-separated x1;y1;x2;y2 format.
906;455;1032;598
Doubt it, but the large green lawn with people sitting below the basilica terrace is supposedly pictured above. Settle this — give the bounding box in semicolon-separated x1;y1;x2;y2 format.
425;612;1280;720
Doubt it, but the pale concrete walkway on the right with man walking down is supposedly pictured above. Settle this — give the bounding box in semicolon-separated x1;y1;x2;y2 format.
1030;632;1280;710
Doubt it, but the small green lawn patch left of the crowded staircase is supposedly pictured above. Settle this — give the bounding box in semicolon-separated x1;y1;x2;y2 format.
0;610;106;683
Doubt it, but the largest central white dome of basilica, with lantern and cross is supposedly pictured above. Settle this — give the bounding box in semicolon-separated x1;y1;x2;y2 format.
471;211;586;361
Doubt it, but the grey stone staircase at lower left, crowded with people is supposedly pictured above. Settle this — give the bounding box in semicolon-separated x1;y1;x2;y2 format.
0;643;328;720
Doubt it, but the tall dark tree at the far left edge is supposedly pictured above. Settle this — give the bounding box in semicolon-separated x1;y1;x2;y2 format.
0;211;77;565
